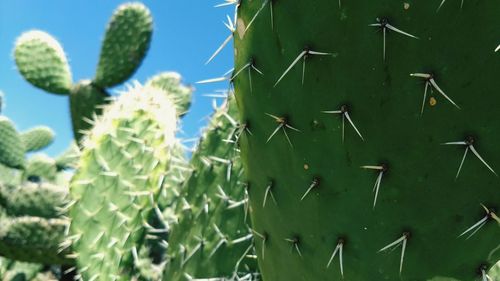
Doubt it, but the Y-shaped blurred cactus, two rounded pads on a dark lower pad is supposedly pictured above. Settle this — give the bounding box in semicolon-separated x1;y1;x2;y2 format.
14;3;153;141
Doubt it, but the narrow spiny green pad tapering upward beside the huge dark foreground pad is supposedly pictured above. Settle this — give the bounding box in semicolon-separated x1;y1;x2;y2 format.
163;99;258;280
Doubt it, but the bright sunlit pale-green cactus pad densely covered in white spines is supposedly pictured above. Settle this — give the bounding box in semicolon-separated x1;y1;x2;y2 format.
69;85;176;281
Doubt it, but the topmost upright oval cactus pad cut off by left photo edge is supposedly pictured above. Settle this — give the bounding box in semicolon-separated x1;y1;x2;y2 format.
0;116;25;168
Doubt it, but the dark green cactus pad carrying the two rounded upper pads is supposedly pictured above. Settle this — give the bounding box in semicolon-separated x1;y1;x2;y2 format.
69;80;109;142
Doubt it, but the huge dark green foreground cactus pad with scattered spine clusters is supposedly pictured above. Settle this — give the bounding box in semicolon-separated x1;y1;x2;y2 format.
234;0;500;281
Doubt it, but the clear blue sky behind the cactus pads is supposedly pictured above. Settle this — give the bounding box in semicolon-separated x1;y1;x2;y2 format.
0;0;234;155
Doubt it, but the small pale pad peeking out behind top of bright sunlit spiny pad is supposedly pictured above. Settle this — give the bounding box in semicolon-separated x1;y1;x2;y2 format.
146;72;194;116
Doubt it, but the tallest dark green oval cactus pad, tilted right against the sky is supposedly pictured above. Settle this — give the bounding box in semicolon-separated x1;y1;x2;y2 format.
94;3;153;88
